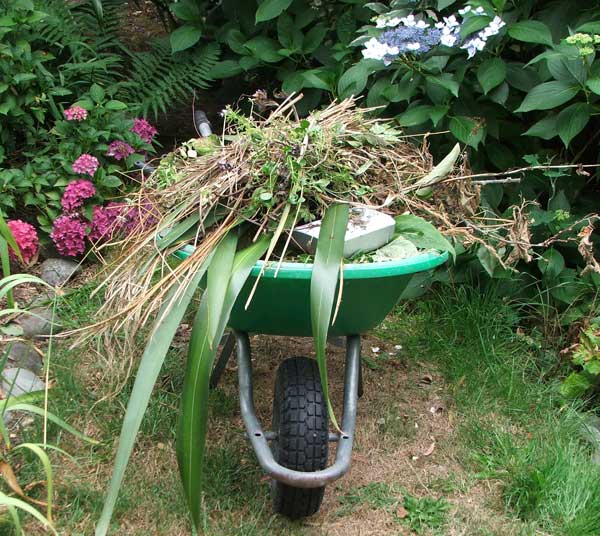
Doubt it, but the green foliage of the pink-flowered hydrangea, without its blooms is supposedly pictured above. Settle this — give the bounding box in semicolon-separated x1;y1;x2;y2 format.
0;84;153;232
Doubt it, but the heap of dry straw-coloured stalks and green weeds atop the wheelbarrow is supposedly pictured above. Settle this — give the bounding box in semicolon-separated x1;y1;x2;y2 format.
88;96;516;348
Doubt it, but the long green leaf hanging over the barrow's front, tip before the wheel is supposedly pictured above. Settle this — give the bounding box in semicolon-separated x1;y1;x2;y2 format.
310;204;349;429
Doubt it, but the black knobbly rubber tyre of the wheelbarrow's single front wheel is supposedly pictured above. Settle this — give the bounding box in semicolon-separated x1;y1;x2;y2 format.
271;357;329;519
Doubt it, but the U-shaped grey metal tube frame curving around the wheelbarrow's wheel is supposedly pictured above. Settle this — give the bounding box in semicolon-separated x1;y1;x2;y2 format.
234;331;360;488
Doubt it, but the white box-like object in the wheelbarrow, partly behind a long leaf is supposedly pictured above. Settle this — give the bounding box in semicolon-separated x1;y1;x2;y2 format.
292;207;396;257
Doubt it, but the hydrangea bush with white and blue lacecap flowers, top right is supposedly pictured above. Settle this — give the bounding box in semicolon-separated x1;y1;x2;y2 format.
338;0;600;161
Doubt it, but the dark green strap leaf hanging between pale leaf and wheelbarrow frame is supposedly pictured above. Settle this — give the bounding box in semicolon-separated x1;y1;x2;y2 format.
177;237;269;527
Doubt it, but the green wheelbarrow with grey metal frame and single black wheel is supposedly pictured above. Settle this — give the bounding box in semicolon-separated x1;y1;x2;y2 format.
177;246;448;519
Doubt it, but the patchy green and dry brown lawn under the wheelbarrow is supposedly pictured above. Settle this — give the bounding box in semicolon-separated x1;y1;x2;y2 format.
8;285;600;536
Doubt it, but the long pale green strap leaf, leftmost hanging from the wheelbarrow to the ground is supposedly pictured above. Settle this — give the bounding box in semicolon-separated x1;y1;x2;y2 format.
96;264;210;536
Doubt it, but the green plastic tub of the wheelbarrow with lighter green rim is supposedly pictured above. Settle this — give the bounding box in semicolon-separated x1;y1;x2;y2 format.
229;252;448;336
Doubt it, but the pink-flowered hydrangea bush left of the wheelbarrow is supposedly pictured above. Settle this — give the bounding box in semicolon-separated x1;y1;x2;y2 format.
0;84;157;234
